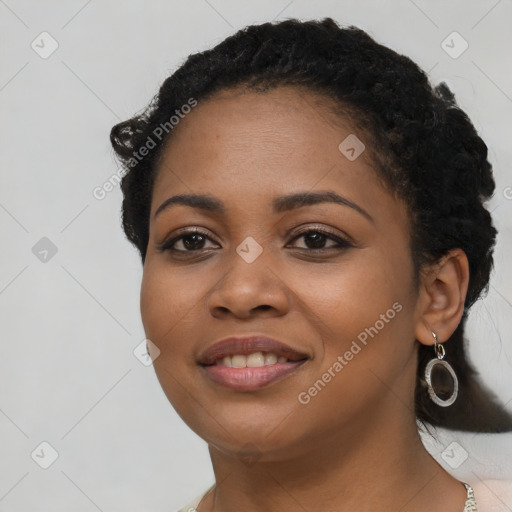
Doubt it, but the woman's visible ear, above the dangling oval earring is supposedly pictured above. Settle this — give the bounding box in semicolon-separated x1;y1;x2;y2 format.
415;249;469;345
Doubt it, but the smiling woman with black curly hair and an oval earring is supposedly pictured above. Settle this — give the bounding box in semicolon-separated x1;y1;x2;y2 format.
111;19;512;512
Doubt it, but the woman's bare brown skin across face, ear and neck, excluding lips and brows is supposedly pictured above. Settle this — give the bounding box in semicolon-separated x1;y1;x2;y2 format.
141;87;468;512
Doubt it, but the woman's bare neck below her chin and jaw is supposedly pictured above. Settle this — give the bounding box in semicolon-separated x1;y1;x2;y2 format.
198;399;466;512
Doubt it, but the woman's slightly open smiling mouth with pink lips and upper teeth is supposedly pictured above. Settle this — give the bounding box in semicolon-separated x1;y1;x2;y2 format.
198;336;310;391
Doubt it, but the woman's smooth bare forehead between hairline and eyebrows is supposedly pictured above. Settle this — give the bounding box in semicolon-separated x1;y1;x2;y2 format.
155;87;374;195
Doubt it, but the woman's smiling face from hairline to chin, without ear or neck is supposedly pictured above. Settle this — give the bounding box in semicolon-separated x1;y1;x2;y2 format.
141;87;417;460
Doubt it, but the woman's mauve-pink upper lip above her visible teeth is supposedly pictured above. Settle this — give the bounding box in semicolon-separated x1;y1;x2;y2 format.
198;335;308;366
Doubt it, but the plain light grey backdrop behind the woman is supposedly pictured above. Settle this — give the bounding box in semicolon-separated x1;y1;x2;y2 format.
0;0;512;512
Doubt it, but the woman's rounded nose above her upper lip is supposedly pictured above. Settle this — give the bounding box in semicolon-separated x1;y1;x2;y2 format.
207;248;290;319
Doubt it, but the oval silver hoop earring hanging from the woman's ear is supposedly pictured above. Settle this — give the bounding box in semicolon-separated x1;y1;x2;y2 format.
425;332;459;407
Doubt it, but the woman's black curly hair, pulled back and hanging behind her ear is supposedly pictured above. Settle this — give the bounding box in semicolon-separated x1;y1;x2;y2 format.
110;18;512;432
